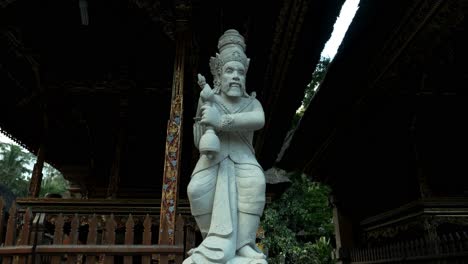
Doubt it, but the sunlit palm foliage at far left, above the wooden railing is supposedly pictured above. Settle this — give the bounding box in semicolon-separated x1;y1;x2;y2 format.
0;142;69;197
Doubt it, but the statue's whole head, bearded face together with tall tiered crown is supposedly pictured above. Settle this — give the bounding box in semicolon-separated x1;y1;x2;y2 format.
210;29;250;97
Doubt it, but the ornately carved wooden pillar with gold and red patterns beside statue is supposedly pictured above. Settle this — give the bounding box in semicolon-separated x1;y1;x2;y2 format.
159;4;189;244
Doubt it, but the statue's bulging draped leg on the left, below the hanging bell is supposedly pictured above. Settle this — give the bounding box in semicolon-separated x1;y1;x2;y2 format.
187;165;219;238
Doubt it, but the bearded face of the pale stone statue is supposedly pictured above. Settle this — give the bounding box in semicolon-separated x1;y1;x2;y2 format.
221;61;245;97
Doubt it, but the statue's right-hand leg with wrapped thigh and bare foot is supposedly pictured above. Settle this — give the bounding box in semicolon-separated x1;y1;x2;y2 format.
236;164;265;259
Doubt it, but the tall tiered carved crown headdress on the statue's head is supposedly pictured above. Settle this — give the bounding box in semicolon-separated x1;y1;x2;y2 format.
210;29;250;92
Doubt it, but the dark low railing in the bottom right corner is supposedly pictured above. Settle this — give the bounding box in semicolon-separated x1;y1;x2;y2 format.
340;232;468;264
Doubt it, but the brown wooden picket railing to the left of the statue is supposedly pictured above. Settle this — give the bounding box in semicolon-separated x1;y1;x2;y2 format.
0;199;190;264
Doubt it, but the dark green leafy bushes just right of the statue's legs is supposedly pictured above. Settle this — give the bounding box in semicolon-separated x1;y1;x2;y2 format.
261;175;333;264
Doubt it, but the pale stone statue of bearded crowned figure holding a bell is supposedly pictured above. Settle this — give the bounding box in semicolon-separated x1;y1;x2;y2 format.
184;29;267;264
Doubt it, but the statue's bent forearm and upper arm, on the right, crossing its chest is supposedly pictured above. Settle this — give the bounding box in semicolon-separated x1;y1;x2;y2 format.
217;99;265;131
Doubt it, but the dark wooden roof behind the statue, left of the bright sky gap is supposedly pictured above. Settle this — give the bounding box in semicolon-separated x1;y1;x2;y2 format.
0;0;344;198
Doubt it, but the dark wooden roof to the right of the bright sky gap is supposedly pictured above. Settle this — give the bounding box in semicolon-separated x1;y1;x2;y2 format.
279;0;468;221
